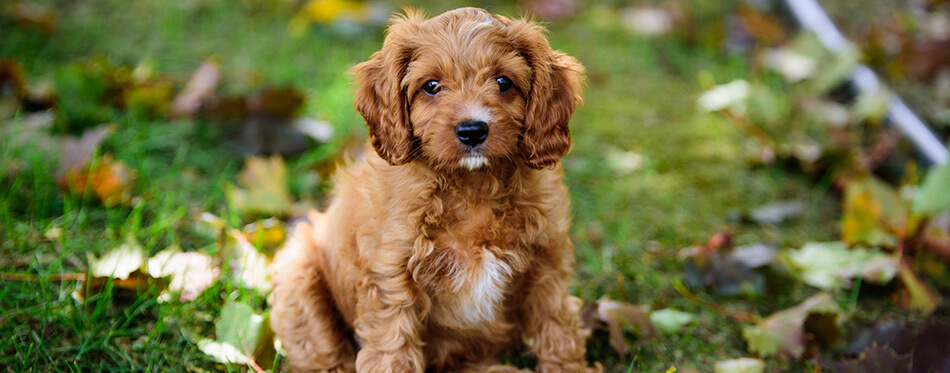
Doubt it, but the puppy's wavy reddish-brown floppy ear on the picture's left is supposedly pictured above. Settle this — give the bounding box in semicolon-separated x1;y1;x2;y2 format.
352;12;422;165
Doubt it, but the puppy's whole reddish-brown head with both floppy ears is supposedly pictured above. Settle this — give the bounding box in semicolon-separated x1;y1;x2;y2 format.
354;8;584;170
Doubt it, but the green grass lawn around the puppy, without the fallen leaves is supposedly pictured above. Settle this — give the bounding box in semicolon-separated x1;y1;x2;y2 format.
0;0;950;372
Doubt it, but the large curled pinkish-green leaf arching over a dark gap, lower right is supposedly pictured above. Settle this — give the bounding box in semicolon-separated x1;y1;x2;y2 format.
742;293;843;358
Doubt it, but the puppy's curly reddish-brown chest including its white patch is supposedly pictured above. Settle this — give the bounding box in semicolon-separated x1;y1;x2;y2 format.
424;201;526;328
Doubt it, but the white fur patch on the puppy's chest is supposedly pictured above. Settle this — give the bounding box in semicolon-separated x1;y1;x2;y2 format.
455;250;512;324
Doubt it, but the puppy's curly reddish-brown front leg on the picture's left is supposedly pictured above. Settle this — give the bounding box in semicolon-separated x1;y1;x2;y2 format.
355;256;426;373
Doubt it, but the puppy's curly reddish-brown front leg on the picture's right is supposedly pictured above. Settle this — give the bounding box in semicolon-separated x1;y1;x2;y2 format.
522;246;599;373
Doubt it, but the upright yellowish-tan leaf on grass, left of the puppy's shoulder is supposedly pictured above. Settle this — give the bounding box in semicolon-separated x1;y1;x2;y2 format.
225;155;293;218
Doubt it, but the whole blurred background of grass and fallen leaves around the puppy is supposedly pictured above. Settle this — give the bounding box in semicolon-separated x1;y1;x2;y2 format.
0;0;950;372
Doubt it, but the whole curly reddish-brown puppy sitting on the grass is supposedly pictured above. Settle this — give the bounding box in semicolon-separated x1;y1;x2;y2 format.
270;8;599;372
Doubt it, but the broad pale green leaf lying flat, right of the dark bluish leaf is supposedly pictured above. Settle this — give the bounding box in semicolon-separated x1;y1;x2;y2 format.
787;241;899;290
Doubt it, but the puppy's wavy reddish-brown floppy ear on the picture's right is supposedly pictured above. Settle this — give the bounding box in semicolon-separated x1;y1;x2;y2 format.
508;20;584;169
